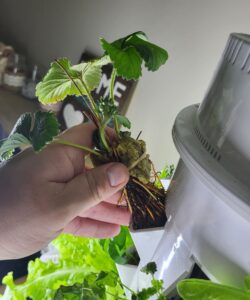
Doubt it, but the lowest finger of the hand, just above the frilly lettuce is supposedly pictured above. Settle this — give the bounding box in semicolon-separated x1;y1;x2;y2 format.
64;217;120;238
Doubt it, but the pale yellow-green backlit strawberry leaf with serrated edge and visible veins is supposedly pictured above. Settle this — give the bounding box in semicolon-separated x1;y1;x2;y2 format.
36;56;106;104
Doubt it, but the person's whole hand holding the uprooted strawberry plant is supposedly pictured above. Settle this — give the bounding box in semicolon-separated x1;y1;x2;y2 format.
0;124;130;259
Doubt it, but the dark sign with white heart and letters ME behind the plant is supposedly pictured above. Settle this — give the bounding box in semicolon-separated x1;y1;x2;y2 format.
58;52;136;130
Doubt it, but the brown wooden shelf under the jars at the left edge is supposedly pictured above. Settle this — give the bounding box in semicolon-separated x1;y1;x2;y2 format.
0;88;39;133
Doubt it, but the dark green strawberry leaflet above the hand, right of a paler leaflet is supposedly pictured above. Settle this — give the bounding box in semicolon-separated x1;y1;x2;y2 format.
30;111;59;151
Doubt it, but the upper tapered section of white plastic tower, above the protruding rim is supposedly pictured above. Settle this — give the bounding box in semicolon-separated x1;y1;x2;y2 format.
196;34;250;189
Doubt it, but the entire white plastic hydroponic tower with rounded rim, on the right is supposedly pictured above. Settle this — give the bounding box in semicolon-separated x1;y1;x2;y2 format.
151;34;250;290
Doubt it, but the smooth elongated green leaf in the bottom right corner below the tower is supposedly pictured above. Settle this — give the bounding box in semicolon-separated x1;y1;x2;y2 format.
177;279;250;300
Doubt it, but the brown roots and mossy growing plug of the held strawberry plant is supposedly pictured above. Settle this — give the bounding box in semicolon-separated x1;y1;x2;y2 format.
91;132;167;230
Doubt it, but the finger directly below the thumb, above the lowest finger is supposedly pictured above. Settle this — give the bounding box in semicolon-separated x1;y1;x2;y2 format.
79;202;131;225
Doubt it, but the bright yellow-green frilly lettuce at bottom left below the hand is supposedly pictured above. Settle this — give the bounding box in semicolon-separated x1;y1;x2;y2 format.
1;234;124;300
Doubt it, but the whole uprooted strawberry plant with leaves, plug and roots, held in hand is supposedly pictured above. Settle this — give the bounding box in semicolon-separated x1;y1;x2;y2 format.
0;31;168;229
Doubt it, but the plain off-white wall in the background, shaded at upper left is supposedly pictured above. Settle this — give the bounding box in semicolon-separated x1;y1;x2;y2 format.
0;0;250;168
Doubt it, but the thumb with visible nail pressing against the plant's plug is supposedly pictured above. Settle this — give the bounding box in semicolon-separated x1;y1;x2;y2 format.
60;163;129;221
